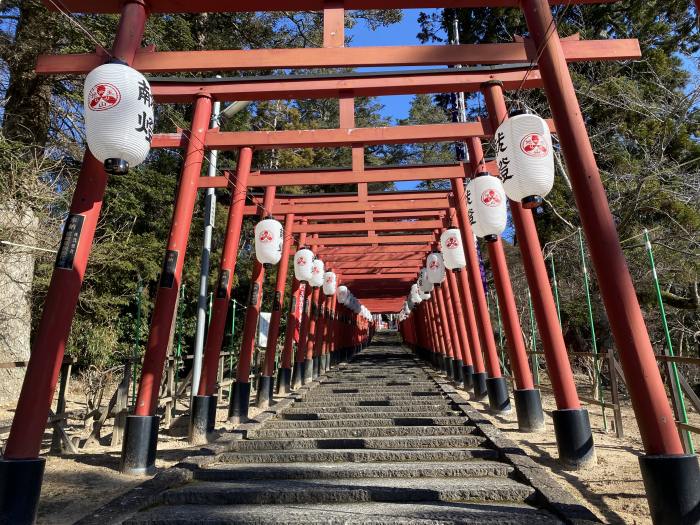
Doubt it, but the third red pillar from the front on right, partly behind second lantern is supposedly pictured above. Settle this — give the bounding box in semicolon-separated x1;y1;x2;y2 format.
467;139;544;432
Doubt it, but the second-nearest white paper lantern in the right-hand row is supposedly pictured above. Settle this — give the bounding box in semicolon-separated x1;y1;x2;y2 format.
467;172;508;242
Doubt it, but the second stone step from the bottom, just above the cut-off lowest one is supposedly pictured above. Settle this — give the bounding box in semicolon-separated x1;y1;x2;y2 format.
158;477;534;505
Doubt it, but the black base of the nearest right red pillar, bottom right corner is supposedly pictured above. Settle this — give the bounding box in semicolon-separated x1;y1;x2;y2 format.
639;454;700;525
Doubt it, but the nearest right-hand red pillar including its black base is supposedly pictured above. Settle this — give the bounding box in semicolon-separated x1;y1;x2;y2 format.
520;4;700;523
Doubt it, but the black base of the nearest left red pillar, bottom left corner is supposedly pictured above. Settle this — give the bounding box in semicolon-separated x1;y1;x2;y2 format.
0;458;46;525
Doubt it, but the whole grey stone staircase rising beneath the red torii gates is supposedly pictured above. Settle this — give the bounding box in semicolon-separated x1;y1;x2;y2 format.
127;338;561;525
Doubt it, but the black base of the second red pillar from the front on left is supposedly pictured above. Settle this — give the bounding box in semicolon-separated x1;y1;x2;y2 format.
119;416;160;476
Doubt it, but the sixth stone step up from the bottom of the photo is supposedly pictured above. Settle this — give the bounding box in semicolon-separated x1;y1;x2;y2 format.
248;425;482;439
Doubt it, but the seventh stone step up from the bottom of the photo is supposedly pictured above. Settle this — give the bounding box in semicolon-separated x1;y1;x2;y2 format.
264;412;469;430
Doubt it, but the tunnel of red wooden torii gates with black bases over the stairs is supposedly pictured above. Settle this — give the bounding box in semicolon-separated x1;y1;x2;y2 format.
0;0;700;523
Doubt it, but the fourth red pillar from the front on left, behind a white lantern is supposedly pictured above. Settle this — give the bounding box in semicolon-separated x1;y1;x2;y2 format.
228;186;275;423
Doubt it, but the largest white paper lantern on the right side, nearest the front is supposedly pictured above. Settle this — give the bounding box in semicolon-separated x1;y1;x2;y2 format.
496;113;554;208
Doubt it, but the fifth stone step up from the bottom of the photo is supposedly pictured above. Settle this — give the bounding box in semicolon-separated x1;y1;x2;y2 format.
231;435;486;452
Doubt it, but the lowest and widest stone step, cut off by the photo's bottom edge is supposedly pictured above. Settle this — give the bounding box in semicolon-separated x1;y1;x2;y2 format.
125;502;562;525
